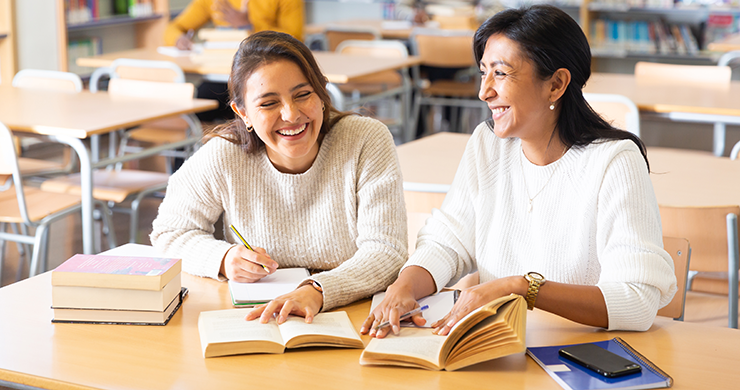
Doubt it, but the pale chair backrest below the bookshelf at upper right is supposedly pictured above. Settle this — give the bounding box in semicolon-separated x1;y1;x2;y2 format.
635;61;732;89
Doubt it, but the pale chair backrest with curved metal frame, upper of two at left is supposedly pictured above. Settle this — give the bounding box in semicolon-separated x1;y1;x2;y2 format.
90;58;185;92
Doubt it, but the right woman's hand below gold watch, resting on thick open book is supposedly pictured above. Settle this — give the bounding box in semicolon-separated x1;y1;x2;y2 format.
432;276;524;336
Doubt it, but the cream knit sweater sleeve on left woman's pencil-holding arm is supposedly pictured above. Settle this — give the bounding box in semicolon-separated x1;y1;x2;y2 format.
150;139;236;279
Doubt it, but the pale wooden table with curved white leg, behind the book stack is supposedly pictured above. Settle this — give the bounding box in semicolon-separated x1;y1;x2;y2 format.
0;86;218;253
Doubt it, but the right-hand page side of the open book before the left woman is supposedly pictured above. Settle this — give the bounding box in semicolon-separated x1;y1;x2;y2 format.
278;311;363;348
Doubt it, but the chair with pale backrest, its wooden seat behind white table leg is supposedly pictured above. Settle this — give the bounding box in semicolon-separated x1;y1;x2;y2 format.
41;78;194;243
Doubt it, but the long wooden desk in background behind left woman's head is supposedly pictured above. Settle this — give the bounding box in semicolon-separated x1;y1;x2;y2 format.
77;49;420;84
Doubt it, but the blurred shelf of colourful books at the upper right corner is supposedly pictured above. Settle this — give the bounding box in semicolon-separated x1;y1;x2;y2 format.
581;0;740;63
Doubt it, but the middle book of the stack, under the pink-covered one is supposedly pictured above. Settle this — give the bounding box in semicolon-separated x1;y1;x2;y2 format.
51;274;182;312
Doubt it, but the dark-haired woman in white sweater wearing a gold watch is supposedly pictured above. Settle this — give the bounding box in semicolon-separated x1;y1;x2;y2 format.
361;5;676;337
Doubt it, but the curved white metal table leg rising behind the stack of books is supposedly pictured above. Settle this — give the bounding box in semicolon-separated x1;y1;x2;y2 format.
49;136;94;254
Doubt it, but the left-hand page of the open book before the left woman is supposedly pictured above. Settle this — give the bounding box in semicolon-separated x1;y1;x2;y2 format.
198;309;283;345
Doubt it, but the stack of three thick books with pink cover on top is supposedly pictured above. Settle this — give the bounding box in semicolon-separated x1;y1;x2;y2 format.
51;254;187;325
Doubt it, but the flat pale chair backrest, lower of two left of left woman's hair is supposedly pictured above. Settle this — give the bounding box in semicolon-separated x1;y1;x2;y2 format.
108;79;195;100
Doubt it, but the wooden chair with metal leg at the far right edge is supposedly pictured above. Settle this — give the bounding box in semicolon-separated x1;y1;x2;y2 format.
660;206;740;328
